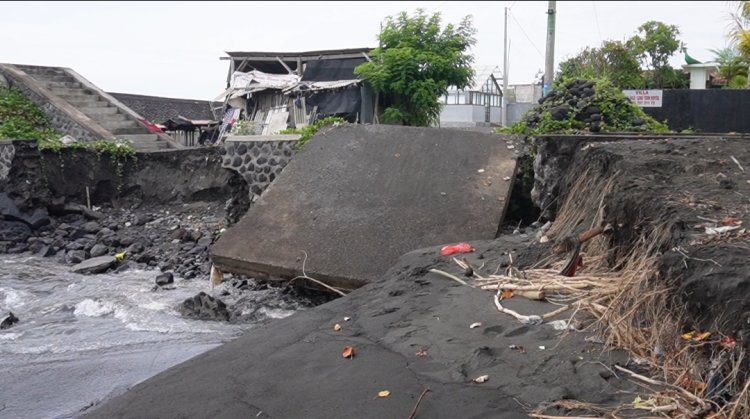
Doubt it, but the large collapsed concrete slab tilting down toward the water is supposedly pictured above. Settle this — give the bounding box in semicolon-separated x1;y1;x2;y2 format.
212;125;516;289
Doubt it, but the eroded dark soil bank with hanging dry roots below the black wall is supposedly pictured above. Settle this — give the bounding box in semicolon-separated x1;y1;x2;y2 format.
531;137;750;417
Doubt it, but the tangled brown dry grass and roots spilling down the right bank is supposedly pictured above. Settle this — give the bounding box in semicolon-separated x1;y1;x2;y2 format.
477;172;750;419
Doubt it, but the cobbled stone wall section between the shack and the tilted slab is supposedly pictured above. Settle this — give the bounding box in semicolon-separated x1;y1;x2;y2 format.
221;135;298;201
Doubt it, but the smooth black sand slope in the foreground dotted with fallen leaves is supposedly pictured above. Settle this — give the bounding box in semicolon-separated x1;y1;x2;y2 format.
86;237;635;418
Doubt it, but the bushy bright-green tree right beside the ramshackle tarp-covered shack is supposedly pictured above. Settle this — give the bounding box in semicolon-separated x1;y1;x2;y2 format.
355;9;476;126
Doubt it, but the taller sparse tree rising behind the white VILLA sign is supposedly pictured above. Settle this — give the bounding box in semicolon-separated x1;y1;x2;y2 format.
627;20;684;89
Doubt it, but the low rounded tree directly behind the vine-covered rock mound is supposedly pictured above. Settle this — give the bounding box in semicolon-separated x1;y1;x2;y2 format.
558;41;645;89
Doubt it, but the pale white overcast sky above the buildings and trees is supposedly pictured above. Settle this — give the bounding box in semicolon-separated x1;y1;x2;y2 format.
0;1;732;99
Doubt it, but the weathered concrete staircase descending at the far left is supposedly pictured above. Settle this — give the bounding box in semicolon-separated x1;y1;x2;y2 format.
7;64;171;151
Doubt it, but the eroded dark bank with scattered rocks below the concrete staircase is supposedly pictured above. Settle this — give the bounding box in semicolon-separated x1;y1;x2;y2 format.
0;141;249;279
